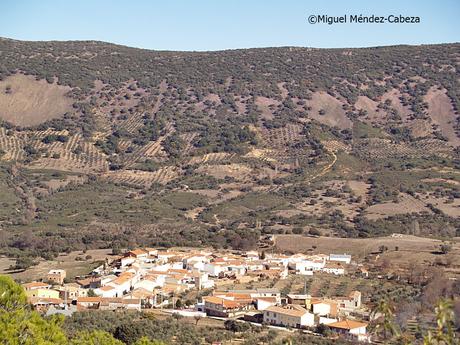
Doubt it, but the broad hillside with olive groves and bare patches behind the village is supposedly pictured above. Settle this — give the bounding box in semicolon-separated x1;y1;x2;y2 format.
0;39;460;256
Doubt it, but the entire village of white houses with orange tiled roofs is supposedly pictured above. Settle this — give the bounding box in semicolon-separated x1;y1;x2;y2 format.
23;248;369;341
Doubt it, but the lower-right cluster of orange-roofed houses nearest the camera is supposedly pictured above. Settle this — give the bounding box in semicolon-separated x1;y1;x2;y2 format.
197;289;368;341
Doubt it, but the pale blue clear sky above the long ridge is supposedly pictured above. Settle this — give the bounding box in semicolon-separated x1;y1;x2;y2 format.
0;0;460;51
